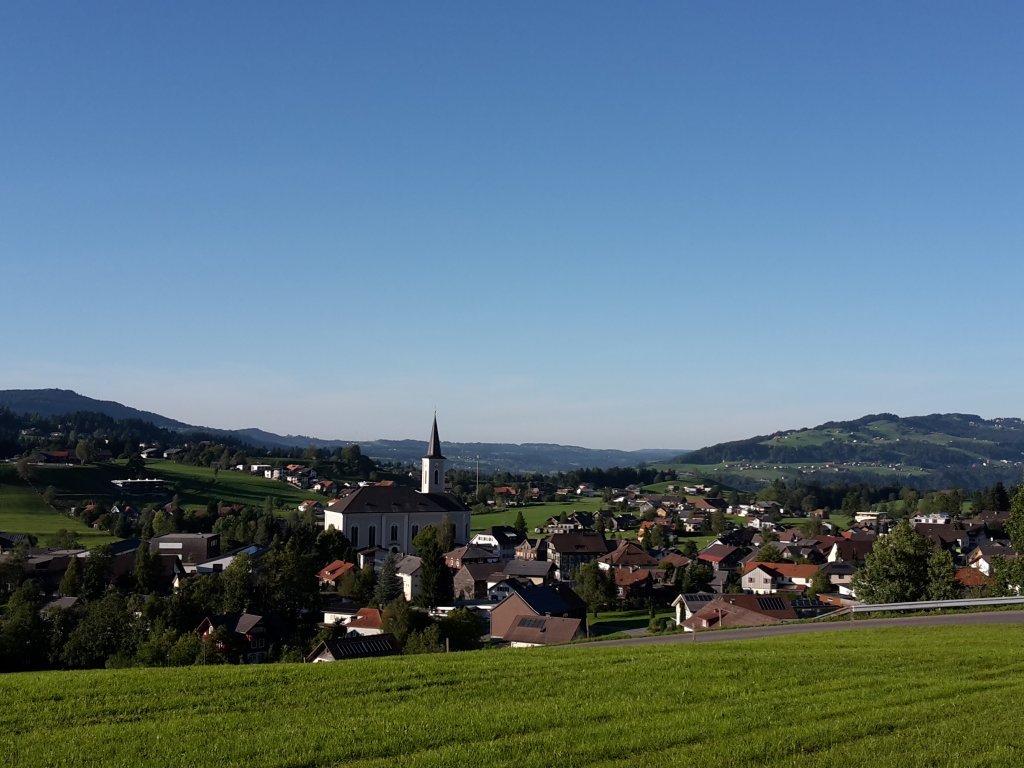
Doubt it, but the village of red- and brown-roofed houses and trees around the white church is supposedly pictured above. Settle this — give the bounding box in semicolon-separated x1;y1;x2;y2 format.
0;419;1017;667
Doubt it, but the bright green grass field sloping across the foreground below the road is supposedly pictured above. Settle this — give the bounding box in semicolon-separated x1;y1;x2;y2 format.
0;626;1024;768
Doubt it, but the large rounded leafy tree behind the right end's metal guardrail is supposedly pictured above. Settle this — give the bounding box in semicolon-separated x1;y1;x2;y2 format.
853;520;932;603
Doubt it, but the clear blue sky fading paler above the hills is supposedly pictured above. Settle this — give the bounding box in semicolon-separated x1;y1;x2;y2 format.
0;0;1024;449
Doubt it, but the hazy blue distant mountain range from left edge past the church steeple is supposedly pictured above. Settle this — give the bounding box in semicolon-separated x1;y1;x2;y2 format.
0;389;685;472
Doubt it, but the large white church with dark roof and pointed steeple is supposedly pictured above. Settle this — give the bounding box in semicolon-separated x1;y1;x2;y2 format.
324;416;470;553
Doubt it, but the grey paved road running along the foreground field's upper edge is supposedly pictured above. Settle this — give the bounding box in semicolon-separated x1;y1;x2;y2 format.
574;610;1024;648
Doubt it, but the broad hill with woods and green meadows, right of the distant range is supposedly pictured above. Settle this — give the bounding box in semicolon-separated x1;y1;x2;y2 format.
676;414;1024;488
